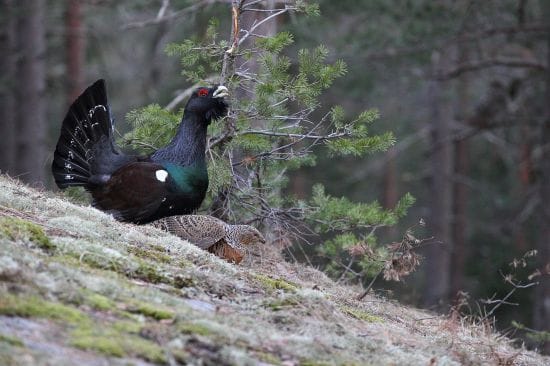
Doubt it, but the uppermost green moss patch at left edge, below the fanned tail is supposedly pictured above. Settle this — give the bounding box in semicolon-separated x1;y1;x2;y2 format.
0;217;55;250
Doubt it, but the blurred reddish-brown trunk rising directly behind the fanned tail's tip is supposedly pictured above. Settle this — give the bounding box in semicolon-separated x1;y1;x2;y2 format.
65;0;85;105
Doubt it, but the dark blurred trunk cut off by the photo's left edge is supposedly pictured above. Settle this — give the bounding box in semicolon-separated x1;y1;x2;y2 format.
0;0;16;173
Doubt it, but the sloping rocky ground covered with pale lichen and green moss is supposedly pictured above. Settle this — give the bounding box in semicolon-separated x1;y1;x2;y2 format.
0;177;550;366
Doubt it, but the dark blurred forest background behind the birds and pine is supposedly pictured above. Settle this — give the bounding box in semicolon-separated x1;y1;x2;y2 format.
0;0;550;352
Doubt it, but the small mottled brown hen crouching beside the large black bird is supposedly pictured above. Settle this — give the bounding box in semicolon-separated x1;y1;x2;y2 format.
151;215;265;264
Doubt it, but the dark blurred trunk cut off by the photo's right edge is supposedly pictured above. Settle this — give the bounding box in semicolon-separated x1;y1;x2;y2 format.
534;2;550;354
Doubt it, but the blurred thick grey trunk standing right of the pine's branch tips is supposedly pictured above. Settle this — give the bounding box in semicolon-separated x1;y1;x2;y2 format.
422;52;453;309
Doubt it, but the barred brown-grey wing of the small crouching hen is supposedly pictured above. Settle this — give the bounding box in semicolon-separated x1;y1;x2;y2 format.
152;215;225;249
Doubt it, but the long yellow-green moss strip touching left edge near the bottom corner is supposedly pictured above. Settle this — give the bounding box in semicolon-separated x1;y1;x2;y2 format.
0;294;89;324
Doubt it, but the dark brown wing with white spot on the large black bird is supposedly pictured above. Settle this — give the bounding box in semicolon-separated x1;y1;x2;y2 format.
91;162;171;223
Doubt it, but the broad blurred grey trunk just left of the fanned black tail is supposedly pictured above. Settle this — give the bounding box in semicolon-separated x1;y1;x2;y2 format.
15;0;47;184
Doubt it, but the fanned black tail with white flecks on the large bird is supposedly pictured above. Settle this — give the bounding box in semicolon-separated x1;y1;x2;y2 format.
52;80;112;188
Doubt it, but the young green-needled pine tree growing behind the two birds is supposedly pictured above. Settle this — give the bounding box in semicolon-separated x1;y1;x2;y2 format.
124;0;414;288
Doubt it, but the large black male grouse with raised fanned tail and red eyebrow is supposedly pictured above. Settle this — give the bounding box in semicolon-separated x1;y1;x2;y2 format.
52;80;228;224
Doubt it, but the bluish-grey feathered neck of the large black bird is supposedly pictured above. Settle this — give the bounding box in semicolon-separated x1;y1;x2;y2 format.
152;113;206;166
